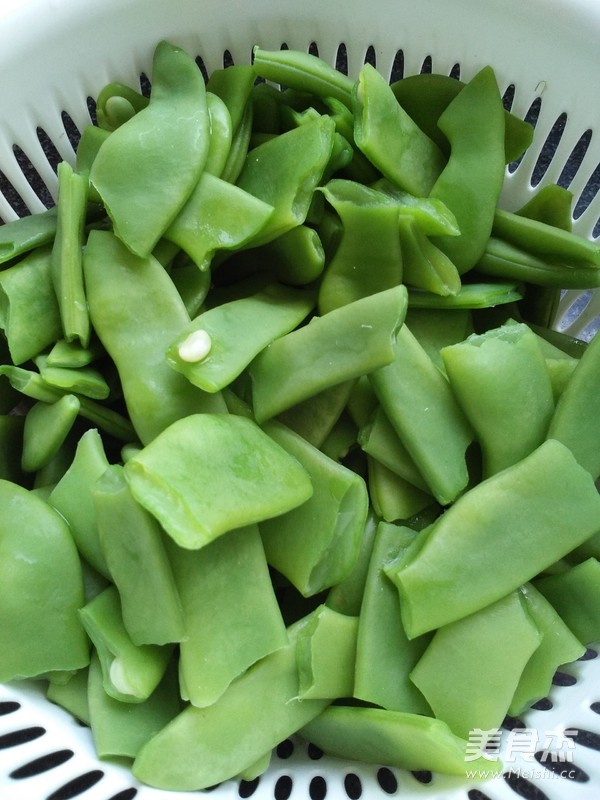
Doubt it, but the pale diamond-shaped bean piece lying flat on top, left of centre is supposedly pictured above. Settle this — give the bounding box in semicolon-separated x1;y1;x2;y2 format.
125;413;313;549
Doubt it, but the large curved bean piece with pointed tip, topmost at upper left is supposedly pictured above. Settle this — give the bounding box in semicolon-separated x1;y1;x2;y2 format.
90;42;209;256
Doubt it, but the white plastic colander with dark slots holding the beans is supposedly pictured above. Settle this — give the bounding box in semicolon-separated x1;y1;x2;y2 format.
0;0;600;800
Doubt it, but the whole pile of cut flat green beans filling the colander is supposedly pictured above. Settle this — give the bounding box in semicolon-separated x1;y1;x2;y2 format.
0;41;600;791
